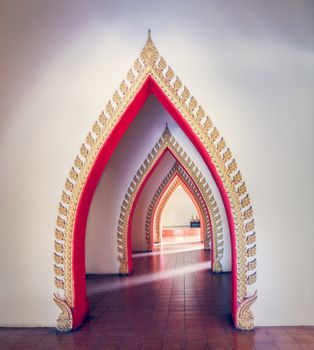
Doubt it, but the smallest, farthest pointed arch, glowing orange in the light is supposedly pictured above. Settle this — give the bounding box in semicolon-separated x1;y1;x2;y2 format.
152;175;205;245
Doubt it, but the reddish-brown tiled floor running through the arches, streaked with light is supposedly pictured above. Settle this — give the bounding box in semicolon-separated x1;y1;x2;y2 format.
0;243;314;350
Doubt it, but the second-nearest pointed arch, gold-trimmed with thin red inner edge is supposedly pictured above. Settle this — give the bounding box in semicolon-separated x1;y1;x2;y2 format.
117;127;223;275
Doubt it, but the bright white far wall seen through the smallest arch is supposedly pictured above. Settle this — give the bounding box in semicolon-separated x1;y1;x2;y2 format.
162;187;198;227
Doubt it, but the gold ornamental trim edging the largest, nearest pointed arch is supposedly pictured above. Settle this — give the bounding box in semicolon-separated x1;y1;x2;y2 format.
54;31;256;328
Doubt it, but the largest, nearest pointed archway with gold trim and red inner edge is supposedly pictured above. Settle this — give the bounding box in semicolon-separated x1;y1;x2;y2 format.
54;32;256;330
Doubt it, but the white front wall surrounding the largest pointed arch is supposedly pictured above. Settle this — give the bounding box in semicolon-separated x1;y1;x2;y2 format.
0;0;314;326
